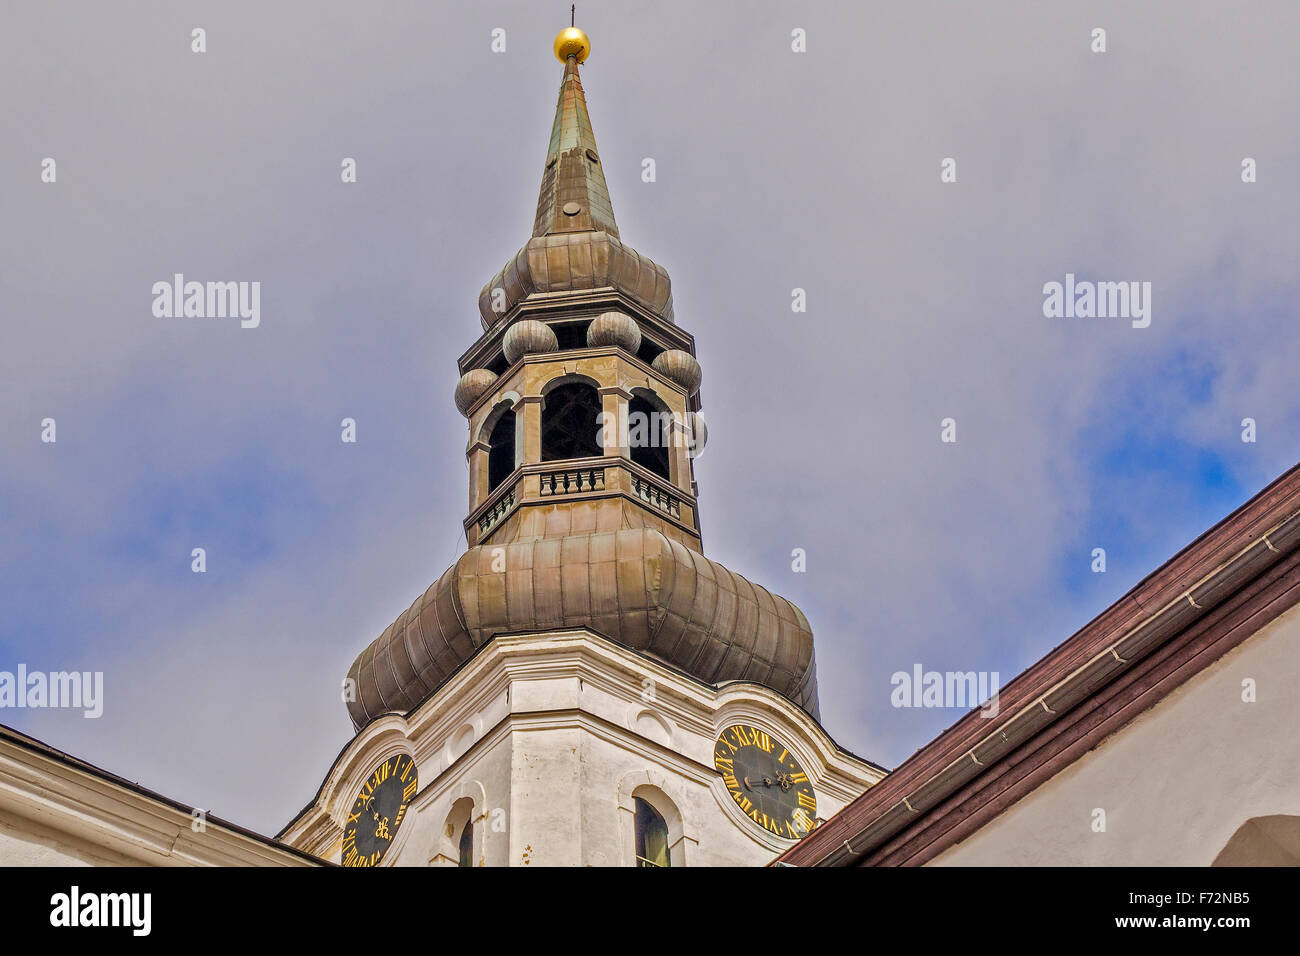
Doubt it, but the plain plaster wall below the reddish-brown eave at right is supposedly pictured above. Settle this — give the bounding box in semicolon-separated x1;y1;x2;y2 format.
933;606;1300;866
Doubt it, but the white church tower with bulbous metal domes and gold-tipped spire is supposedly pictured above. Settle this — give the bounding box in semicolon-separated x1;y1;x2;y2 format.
281;27;884;866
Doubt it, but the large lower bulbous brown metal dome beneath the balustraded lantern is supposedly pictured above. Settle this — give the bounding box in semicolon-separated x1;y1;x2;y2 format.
347;528;819;730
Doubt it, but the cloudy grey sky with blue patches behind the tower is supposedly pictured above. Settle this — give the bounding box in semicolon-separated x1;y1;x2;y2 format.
0;0;1300;834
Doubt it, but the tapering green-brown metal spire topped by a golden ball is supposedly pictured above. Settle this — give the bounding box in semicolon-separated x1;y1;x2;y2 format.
533;40;619;243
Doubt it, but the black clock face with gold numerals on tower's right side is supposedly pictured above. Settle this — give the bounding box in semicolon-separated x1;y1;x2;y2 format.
714;723;816;840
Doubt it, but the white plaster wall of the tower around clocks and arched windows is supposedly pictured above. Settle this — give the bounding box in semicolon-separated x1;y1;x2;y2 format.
295;631;881;866
